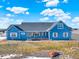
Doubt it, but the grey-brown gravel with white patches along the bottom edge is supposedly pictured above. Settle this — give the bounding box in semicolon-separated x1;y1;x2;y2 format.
0;51;73;59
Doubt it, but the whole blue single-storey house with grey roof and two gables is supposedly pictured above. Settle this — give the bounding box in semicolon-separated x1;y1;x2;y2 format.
6;21;72;40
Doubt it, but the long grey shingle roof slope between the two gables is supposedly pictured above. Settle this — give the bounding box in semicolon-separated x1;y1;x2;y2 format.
18;22;55;32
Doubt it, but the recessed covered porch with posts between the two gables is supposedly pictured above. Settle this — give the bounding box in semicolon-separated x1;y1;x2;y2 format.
27;32;48;40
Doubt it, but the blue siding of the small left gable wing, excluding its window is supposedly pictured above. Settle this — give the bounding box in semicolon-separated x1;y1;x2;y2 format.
6;26;27;40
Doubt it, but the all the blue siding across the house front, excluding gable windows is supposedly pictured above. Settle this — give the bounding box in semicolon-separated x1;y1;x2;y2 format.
6;22;72;40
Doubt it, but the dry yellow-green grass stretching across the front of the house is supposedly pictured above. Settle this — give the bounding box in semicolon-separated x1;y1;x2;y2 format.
0;41;79;59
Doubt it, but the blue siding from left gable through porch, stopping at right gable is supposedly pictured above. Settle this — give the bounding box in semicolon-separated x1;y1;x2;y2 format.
7;26;48;40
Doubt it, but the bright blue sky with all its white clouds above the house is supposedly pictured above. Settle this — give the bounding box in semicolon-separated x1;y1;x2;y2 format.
0;0;79;28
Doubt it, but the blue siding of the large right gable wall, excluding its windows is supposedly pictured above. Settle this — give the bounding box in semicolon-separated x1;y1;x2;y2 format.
49;22;72;40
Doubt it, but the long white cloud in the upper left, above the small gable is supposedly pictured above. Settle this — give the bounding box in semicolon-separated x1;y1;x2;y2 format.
6;7;28;14
